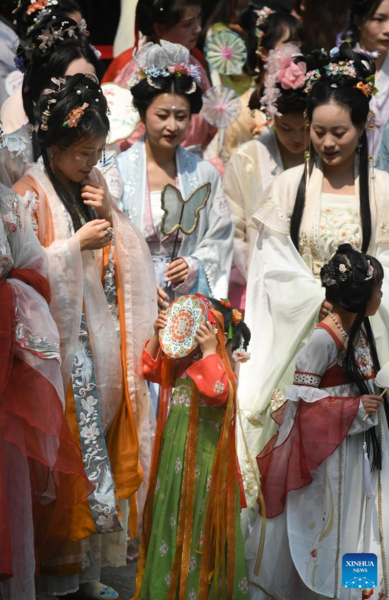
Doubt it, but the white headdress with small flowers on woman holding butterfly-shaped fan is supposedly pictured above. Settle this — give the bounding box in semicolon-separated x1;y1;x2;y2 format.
130;40;201;94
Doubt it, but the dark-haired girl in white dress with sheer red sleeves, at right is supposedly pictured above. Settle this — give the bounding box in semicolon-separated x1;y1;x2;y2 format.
246;244;389;600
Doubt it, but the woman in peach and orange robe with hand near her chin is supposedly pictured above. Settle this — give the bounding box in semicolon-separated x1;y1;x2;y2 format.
14;74;156;599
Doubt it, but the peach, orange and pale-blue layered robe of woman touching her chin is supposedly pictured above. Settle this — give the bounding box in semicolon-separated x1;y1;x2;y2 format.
15;165;156;594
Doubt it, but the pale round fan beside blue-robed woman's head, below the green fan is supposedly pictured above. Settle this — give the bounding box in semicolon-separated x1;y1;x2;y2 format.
202;85;242;129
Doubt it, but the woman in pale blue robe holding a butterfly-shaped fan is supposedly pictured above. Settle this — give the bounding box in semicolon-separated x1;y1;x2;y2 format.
107;40;234;308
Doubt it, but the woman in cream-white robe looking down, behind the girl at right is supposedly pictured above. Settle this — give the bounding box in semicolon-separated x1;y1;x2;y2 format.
238;44;389;535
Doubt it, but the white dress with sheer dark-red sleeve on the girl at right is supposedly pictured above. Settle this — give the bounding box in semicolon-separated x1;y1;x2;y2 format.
246;324;389;600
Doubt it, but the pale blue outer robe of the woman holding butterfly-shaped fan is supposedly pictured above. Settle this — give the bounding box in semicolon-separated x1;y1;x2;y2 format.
111;140;234;298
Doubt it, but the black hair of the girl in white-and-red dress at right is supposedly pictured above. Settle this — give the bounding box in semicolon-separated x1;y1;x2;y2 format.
320;244;389;470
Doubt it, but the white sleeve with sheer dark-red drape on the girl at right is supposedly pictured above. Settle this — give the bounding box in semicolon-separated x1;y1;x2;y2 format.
257;329;360;518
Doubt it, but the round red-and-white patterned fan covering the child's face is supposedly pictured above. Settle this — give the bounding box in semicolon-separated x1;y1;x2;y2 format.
159;294;215;359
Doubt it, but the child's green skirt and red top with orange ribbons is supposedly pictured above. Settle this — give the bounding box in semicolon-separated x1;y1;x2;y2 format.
135;351;248;600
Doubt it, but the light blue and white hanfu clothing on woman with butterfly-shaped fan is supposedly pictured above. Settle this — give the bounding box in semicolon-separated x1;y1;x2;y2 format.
106;139;234;298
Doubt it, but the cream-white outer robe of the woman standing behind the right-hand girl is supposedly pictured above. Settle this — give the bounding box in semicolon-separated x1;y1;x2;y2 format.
238;166;389;510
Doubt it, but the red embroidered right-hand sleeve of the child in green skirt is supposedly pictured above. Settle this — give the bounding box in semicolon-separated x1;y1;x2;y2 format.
187;354;230;406
